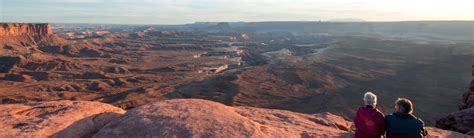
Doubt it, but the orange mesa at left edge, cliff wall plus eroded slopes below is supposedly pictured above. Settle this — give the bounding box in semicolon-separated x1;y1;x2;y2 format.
0;23;68;73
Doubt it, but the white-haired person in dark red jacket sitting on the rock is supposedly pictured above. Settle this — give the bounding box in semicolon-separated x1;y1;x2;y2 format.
354;92;385;138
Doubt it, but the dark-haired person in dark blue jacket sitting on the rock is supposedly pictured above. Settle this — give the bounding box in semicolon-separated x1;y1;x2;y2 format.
385;98;428;138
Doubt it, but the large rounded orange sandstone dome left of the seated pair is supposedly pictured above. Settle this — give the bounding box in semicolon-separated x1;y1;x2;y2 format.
93;99;352;137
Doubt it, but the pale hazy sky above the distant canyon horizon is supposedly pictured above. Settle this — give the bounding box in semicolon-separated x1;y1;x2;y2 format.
0;0;474;24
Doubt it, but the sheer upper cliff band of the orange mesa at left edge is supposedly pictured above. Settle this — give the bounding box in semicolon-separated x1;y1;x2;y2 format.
0;23;53;36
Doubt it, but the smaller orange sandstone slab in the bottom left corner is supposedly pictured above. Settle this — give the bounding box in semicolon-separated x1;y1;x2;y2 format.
0;101;125;138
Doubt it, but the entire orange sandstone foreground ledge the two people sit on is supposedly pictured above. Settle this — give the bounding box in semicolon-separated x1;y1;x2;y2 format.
0;99;469;138
